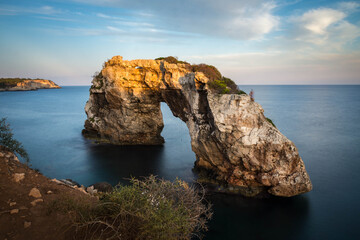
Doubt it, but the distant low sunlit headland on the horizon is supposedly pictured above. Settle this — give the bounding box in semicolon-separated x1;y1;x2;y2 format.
0;78;61;92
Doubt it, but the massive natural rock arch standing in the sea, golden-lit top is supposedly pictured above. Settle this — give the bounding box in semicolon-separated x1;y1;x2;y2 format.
83;56;312;196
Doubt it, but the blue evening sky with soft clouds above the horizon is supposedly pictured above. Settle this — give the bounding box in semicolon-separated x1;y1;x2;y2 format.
0;0;360;86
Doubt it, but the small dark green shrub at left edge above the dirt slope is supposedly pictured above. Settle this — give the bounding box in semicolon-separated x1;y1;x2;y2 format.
0;118;30;164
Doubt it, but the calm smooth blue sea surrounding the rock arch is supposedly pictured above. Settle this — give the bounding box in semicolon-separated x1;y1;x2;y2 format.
0;86;360;240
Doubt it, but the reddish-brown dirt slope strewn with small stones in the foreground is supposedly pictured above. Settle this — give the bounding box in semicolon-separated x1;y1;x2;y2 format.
0;146;96;240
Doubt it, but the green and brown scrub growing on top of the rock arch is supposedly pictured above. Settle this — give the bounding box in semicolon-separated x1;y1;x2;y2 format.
155;56;246;94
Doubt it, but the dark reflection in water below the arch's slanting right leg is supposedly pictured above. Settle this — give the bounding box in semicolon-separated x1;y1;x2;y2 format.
205;194;310;240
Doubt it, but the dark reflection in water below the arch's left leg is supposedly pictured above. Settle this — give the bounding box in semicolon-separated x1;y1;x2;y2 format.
87;143;164;185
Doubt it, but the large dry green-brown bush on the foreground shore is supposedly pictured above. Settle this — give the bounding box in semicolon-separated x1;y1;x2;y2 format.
52;176;212;240
